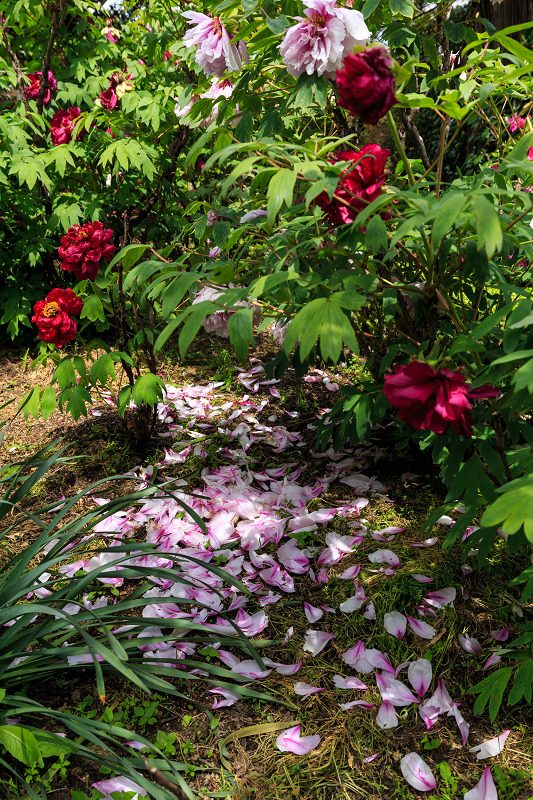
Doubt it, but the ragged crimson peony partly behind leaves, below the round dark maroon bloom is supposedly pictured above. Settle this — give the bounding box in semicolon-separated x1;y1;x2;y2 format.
316;144;390;226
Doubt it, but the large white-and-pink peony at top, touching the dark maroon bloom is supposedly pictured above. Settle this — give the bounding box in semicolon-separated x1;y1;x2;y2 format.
279;0;370;77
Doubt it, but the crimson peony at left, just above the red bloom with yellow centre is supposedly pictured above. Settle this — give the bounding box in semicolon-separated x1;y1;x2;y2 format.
58;222;117;281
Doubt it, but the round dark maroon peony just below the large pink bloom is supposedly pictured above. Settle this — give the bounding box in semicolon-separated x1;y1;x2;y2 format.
336;47;398;125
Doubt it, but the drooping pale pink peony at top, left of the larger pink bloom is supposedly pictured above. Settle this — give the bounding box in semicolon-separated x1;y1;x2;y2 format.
183;11;242;77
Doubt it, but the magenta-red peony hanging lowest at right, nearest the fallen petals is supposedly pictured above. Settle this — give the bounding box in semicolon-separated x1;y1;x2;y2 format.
383;361;499;436
